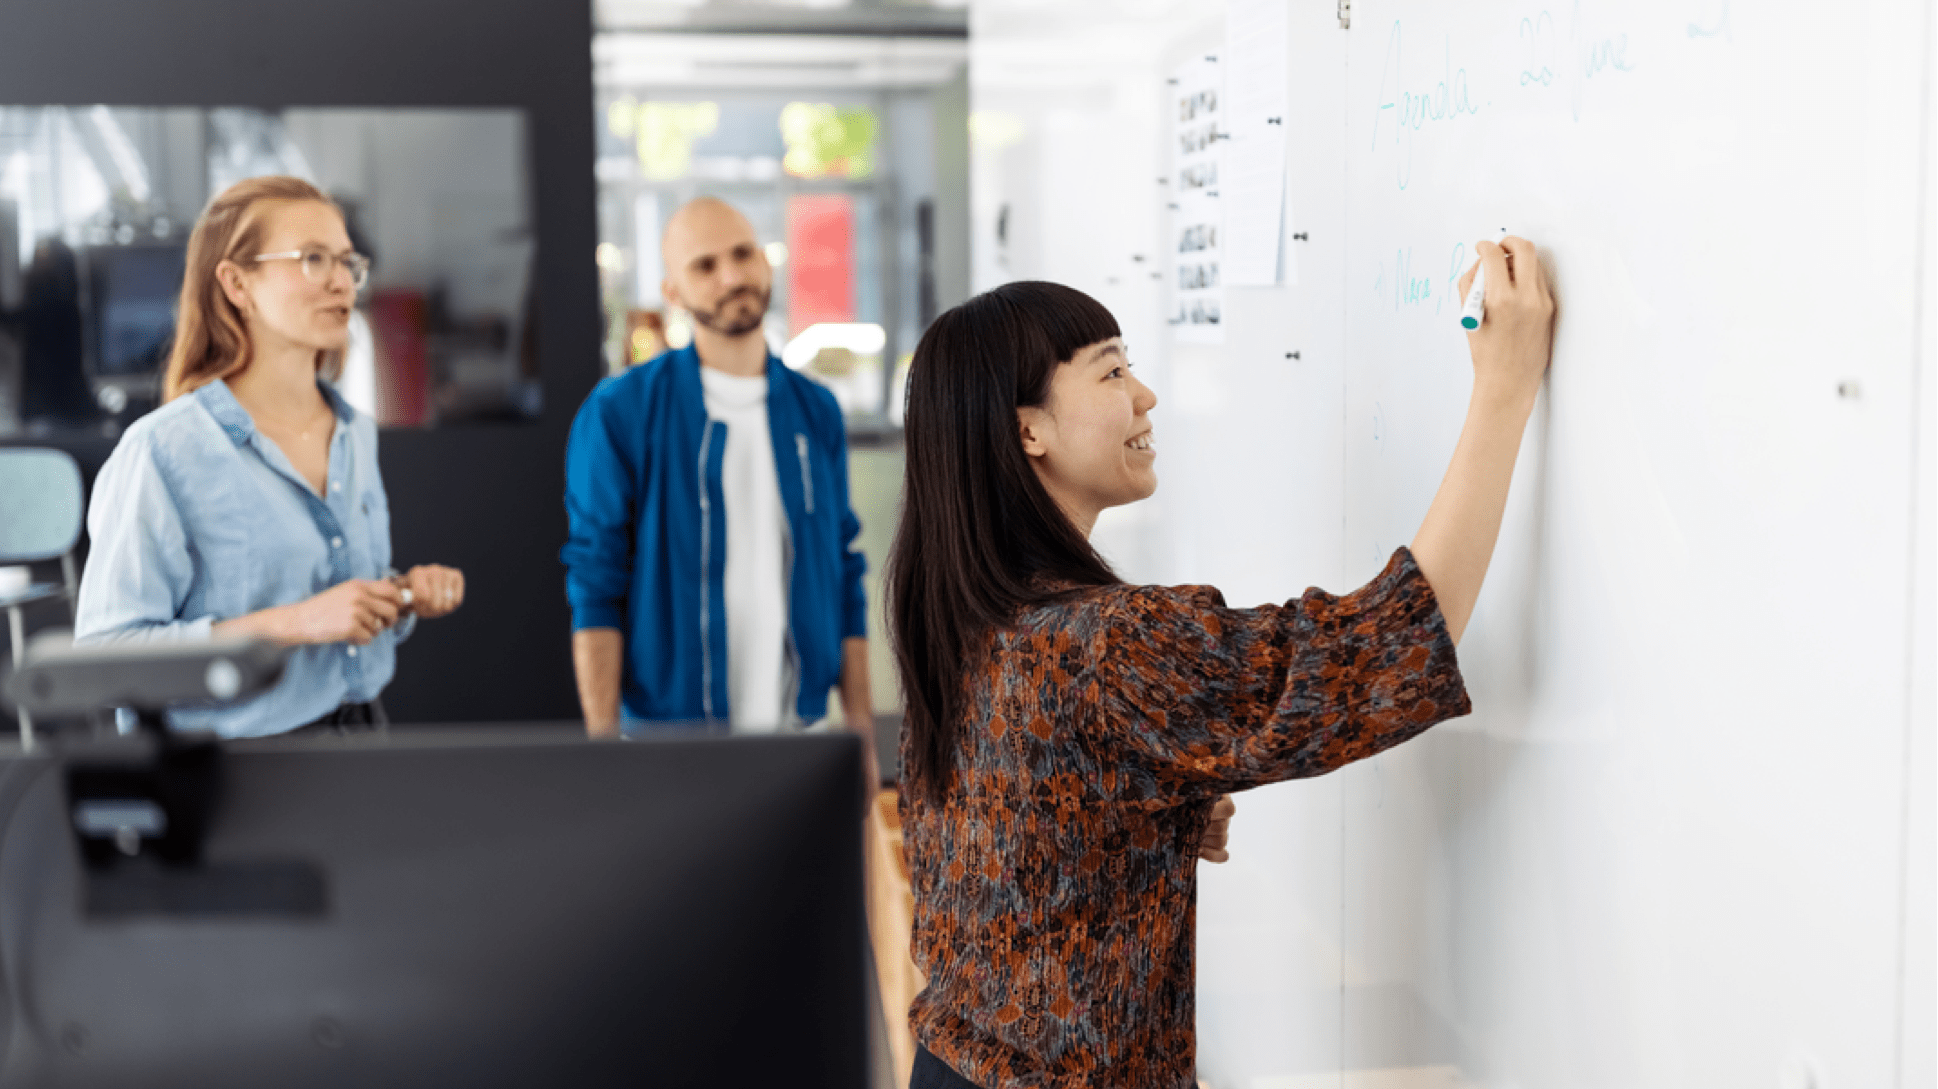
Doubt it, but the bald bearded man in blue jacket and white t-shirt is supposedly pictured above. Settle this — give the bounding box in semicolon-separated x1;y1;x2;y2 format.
562;198;876;781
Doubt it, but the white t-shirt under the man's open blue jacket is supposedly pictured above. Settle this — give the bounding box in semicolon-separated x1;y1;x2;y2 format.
700;366;795;732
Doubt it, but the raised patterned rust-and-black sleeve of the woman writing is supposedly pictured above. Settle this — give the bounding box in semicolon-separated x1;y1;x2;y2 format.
1095;548;1473;794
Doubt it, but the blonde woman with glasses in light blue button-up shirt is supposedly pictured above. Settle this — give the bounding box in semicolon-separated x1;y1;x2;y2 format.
76;176;465;738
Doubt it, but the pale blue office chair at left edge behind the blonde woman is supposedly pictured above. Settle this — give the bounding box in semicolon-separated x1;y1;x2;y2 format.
0;448;85;748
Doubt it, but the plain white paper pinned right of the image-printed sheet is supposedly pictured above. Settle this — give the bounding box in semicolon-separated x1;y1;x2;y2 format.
1219;0;1297;287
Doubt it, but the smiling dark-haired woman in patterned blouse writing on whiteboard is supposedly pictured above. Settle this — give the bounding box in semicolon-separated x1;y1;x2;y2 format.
888;238;1554;1089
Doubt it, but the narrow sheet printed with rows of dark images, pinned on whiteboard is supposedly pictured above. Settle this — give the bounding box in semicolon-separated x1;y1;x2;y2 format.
1169;56;1225;345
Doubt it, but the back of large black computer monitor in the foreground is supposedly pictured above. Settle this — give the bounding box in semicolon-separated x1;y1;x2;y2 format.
0;729;868;1089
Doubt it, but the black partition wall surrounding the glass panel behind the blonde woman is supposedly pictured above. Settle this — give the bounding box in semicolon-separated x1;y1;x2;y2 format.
0;0;601;723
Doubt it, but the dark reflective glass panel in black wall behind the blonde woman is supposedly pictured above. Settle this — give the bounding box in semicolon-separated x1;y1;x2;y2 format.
0;105;543;436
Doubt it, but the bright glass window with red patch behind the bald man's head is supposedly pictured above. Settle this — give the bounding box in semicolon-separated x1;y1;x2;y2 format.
597;87;934;440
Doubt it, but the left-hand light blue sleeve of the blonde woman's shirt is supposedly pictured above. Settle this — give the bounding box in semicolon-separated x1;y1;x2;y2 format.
74;426;215;643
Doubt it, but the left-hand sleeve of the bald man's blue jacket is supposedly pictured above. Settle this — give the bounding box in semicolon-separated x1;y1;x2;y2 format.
560;388;638;632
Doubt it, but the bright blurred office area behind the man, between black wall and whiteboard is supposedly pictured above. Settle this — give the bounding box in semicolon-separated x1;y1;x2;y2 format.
577;0;969;720
